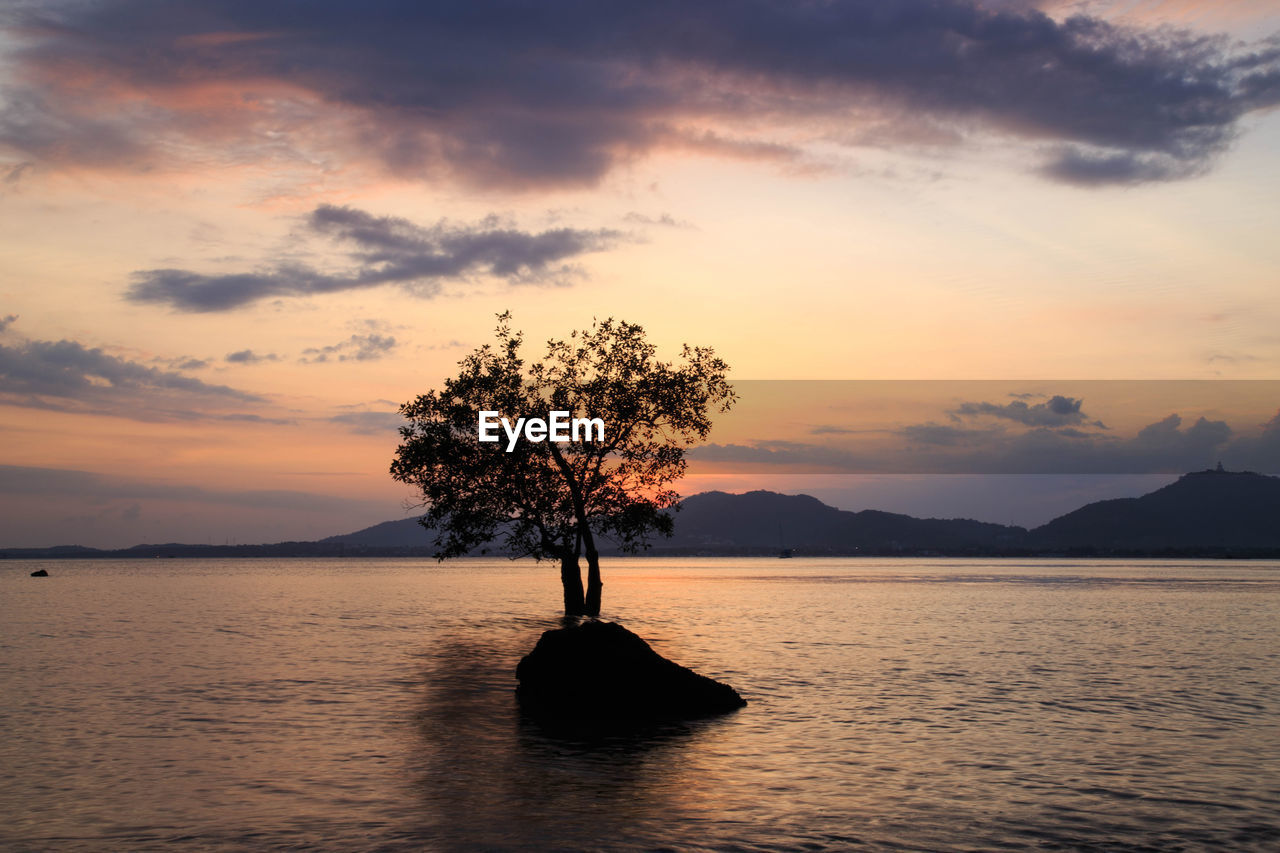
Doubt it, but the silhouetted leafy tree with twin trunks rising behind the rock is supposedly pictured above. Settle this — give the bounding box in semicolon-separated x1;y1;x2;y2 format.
392;314;736;616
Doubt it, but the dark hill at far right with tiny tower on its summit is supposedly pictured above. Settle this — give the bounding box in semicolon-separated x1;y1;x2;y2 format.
1028;470;1280;552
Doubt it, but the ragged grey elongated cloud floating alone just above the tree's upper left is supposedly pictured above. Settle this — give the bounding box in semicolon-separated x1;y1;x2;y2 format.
125;205;620;311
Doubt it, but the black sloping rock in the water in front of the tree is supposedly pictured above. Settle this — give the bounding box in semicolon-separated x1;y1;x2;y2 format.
516;621;746;720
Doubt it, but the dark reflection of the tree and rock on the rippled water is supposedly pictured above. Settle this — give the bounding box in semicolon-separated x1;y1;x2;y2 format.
416;624;722;848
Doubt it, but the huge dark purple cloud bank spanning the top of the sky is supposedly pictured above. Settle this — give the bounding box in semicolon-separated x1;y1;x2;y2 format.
0;0;1280;185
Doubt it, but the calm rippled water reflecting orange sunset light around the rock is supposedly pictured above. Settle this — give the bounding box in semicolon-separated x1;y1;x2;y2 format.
0;558;1280;850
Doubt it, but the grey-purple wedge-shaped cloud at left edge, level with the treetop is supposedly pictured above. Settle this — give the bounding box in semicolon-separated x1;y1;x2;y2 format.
0;339;265;420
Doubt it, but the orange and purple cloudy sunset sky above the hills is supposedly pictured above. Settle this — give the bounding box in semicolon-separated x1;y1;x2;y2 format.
0;0;1280;547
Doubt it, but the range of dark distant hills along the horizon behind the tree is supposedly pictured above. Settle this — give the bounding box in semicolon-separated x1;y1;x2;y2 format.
10;470;1280;560
